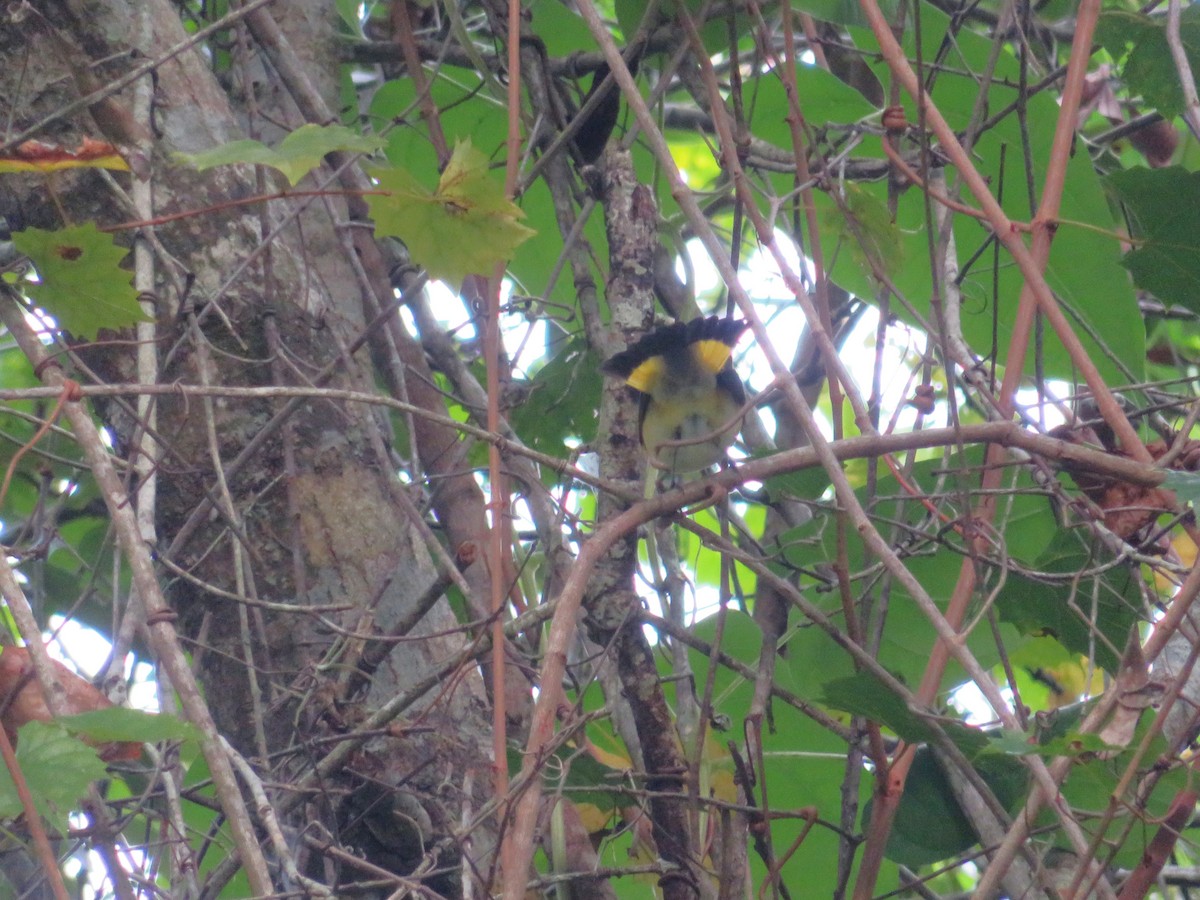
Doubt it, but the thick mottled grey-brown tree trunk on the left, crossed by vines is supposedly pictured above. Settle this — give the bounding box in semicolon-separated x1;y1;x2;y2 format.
0;0;494;895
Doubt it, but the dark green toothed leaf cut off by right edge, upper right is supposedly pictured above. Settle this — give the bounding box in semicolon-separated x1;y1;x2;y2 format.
1105;166;1200;312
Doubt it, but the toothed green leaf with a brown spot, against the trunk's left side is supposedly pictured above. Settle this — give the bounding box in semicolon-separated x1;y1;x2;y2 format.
12;222;150;340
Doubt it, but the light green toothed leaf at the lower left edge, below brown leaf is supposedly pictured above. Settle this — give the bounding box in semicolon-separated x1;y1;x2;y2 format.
0;721;106;826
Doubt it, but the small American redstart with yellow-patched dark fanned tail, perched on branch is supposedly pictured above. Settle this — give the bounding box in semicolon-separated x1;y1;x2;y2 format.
601;316;749;473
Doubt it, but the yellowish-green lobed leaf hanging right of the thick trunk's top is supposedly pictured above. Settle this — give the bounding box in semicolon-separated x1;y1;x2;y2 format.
367;140;534;288
